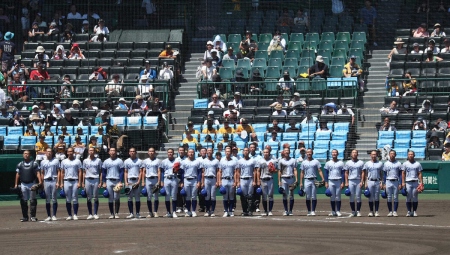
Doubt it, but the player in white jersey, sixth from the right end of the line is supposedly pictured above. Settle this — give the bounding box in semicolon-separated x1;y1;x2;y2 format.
300;149;325;216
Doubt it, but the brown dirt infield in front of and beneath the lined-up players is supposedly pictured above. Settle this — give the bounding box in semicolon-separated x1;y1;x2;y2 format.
0;198;450;254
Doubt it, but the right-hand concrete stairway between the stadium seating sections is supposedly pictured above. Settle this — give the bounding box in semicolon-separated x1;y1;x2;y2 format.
356;50;390;159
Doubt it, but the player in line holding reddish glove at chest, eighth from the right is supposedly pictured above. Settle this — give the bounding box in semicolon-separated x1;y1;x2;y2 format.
257;148;278;216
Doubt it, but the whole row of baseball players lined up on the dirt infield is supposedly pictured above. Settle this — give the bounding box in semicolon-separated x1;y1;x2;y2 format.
14;144;424;222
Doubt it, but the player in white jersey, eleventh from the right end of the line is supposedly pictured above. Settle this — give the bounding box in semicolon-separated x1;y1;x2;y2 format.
202;148;219;217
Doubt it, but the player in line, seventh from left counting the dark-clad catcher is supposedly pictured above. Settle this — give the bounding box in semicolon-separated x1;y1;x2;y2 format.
141;147;161;218
